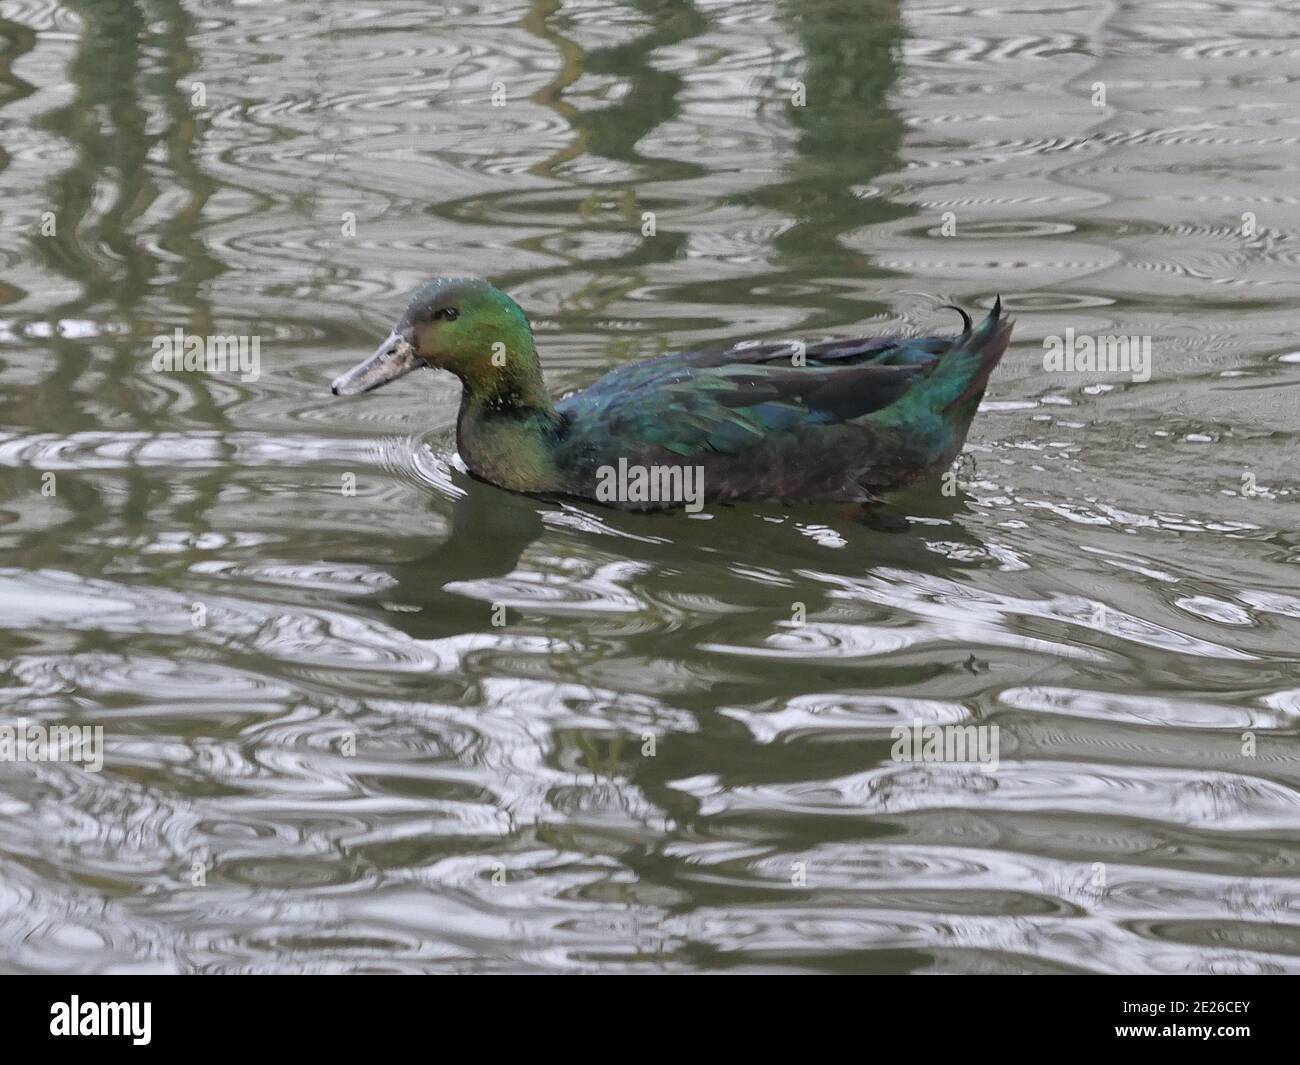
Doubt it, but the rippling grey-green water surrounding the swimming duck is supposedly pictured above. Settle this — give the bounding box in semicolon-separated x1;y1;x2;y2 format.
0;0;1300;973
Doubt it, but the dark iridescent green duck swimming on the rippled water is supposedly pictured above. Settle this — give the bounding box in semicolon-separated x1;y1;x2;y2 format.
332;277;1013;511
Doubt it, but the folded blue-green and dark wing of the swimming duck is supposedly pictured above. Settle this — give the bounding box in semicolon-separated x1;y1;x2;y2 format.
559;337;961;455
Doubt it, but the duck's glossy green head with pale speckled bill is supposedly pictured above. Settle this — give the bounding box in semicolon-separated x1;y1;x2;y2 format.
330;277;540;395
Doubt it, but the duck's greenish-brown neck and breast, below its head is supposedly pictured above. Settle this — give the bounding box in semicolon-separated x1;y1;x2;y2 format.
456;342;560;492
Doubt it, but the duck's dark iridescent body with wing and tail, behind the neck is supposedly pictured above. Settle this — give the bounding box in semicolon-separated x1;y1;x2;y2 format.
555;307;1010;508
